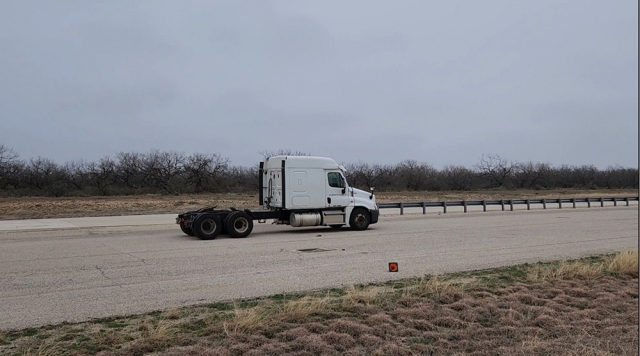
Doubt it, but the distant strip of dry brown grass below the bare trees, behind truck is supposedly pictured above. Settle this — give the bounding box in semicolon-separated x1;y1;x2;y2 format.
0;189;638;220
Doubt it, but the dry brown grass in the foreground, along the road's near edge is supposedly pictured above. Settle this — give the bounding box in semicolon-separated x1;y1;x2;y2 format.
0;251;638;356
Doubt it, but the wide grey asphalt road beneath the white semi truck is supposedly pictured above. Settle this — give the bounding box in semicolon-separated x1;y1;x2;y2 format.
0;205;638;330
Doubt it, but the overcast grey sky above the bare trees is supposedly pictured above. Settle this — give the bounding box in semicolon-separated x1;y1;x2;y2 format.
0;0;638;168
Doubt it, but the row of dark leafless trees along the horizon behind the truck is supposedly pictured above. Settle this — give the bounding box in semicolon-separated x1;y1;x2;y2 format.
0;145;638;197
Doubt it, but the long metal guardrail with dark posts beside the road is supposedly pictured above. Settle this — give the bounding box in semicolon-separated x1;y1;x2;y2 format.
378;197;638;215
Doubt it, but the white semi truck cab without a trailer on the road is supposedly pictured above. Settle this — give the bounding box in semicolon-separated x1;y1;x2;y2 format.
176;156;379;240
